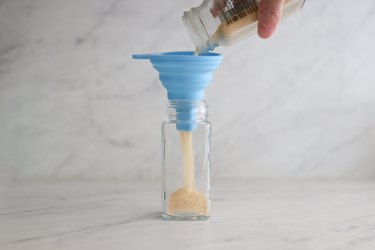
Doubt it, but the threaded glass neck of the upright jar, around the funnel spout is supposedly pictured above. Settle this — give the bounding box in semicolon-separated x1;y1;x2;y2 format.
167;100;208;125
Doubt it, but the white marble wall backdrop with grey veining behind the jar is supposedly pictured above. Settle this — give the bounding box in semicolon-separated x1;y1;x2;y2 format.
0;0;375;179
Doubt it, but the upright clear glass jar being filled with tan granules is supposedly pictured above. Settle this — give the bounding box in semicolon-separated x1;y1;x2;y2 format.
162;100;211;220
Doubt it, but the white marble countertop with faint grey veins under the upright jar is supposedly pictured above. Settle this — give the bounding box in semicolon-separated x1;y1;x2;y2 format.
0;181;375;250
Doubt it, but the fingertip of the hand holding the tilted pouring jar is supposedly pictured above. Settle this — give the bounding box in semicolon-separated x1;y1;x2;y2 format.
258;0;285;38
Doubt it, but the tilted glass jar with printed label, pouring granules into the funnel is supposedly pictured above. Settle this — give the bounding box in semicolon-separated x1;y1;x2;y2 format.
182;0;305;53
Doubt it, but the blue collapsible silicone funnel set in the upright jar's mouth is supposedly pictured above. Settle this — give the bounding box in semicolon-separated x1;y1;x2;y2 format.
133;51;223;131
